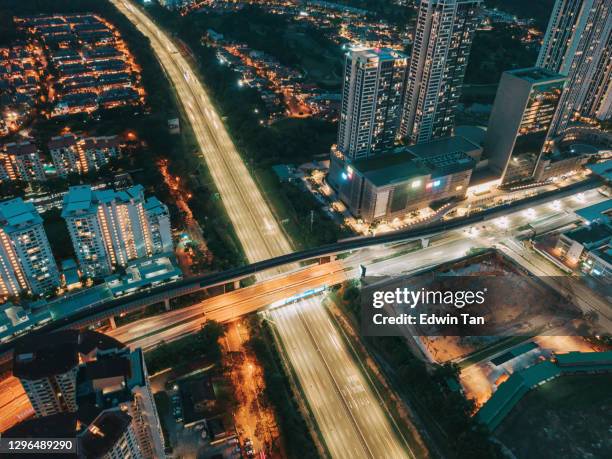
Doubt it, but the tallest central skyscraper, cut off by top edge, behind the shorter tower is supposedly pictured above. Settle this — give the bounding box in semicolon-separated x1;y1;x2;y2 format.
400;0;481;143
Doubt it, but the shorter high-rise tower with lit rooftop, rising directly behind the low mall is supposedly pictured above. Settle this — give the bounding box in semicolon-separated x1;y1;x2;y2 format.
338;48;407;159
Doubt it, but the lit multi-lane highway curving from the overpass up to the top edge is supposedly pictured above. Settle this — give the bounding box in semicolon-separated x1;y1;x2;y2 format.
111;0;292;272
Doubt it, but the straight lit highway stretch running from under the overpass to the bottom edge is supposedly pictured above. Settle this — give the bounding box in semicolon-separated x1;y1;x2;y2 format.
267;296;414;459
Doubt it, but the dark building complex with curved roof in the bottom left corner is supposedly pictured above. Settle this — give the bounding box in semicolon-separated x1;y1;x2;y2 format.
13;330;165;459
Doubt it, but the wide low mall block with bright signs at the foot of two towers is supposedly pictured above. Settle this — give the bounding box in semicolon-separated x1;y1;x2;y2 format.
328;137;480;222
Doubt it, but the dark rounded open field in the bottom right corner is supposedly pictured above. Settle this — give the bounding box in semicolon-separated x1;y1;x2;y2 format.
496;374;612;459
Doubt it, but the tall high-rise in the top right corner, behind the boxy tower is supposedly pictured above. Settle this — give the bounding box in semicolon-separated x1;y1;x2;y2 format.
537;0;612;136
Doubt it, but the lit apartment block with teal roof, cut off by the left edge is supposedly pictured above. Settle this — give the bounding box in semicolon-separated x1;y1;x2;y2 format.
0;198;59;297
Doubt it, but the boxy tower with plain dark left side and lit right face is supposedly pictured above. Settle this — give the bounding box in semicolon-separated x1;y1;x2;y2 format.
484;67;565;184
